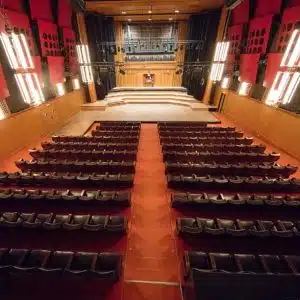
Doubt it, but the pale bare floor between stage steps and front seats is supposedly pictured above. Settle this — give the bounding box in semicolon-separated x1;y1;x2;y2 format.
55;104;219;135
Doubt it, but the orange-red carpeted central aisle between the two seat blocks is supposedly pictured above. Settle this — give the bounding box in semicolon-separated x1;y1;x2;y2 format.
123;124;181;300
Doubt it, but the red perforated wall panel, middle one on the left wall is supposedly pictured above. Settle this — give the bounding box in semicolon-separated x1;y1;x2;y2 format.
37;20;62;57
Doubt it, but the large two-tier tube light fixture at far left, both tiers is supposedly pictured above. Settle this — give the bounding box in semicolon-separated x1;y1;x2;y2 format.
0;32;45;105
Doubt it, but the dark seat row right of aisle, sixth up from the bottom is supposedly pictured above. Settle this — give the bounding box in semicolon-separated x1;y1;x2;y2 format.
163;151;280;163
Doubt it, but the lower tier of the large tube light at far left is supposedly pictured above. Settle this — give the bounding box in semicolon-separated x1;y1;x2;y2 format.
14;73;45;105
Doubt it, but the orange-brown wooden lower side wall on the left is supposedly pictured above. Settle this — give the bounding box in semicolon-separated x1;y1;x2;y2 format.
0;89;85;160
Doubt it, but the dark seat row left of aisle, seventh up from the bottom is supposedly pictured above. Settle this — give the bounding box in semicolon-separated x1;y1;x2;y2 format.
42;142;138;151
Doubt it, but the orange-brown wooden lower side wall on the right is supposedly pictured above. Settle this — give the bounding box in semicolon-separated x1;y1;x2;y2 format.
214;88;300;159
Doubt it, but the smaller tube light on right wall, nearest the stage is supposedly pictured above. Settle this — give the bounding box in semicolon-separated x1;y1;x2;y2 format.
210;42;230;81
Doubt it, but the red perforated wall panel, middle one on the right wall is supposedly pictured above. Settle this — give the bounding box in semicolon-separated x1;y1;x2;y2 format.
245;15;273;54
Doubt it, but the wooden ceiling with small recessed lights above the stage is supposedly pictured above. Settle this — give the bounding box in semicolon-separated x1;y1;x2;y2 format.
86;0;224;21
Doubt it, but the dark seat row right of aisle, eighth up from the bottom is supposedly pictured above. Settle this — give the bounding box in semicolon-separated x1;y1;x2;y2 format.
160;135;253;145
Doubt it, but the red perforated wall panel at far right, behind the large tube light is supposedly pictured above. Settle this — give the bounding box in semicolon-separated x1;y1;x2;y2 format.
276;6;300;53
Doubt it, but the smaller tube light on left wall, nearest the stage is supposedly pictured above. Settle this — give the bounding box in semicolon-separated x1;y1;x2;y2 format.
76;45;94;83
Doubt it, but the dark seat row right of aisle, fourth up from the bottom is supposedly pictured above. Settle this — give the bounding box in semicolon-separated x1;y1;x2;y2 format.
167;174;300;193
